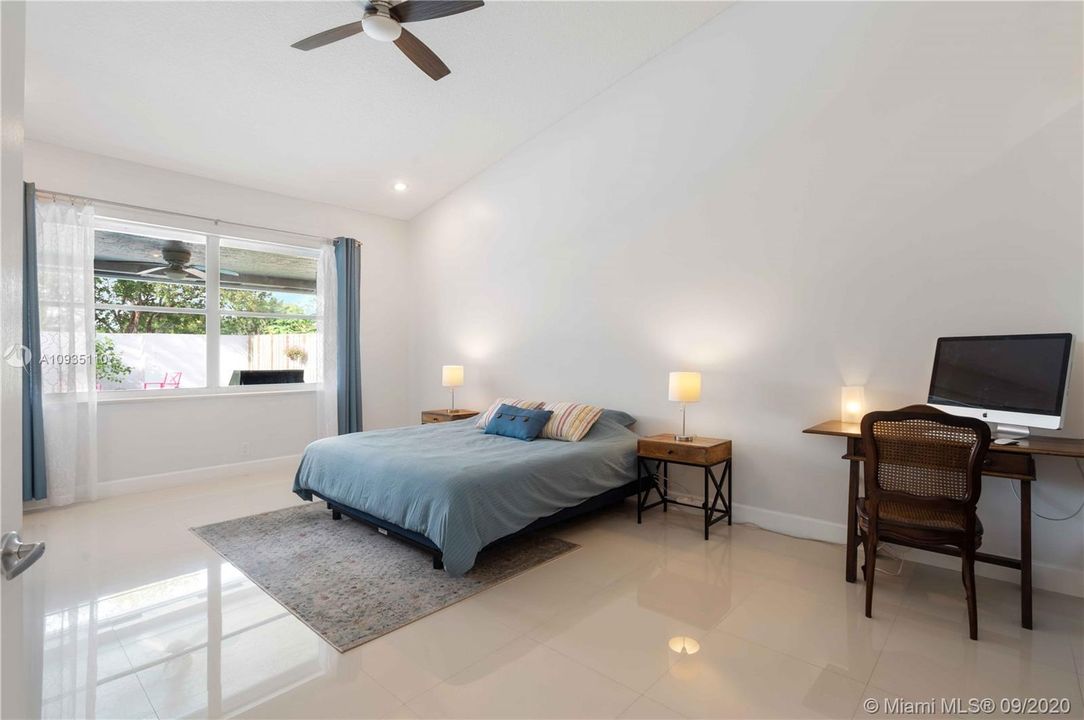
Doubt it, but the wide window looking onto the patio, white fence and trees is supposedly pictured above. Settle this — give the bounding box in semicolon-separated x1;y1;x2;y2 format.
94;218;319;391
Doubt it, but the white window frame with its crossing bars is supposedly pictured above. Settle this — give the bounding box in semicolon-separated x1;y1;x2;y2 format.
93;214;322;402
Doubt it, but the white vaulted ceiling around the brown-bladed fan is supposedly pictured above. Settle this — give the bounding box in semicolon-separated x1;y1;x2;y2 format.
26;0;724;218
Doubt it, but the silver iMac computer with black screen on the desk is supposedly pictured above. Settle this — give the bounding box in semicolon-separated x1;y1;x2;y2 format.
927;333;1073;443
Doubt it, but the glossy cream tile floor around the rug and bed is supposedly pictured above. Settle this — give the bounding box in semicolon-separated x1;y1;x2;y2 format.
25;477;1084;718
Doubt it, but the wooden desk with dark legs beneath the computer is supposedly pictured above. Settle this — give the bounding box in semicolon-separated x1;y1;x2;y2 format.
802;420;1084;630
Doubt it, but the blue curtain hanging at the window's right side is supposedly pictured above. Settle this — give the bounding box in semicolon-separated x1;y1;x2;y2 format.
335;237;361;435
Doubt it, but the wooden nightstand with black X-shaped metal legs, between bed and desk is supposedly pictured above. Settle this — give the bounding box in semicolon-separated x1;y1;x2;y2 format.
636;433;732;540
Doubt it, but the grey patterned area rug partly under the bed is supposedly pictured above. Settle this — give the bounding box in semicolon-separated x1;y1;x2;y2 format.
191;503;579;653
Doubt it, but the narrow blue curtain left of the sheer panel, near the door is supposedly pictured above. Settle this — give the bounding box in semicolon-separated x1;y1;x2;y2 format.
23;182;46;500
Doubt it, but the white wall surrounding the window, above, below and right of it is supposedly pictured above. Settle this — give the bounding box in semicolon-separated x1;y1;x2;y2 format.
25;141;416;483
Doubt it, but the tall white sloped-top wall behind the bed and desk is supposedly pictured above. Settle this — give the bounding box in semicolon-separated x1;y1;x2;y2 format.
410;3;1084;593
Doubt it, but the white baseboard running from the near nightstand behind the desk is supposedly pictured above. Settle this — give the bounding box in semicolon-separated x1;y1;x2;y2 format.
734;503;1084;597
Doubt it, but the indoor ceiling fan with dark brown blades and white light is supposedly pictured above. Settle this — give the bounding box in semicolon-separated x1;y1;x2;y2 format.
291;0;486;80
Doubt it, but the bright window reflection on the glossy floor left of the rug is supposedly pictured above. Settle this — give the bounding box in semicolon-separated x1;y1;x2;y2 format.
42;563;323;718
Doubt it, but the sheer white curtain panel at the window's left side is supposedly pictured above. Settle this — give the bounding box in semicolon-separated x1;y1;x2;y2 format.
36;202;98;505
